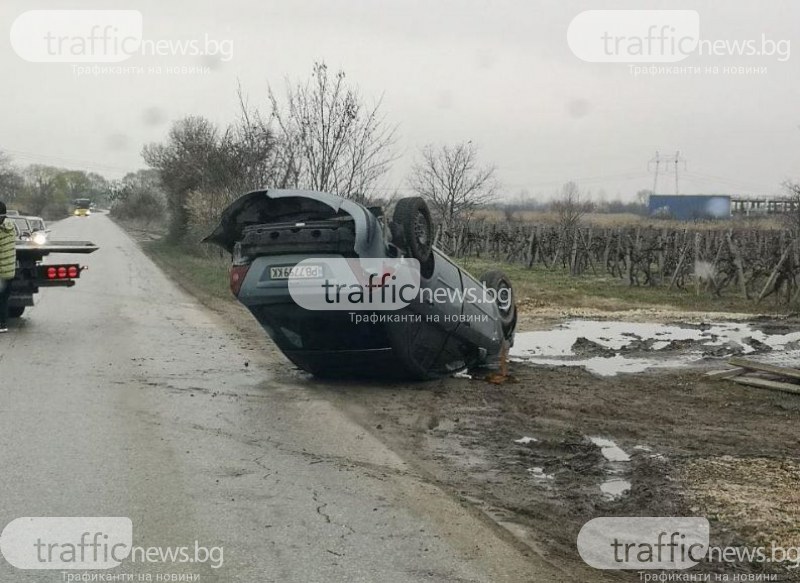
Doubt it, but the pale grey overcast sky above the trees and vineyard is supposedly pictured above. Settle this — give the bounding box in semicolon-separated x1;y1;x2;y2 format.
0;0;800;199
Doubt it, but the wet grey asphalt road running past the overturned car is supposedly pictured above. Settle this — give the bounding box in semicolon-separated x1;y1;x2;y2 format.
0;215;560;582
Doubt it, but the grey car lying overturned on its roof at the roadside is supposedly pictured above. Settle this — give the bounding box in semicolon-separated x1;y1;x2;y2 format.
205;190;517;379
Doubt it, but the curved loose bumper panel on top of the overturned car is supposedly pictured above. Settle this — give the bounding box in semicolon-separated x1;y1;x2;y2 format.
203;189;382;255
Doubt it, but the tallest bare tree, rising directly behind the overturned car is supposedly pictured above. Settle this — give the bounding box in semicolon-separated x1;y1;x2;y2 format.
269;63;397;202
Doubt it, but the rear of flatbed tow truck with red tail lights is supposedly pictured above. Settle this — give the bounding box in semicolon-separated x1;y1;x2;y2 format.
8;240;99;318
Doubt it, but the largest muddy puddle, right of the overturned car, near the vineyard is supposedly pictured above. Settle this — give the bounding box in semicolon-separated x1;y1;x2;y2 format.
510;320;800;376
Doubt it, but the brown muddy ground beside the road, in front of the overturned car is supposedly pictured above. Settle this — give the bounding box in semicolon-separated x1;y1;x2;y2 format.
300;320;800;580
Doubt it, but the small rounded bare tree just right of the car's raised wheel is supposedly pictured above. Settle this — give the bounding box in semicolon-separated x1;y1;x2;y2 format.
408;142;498;232
